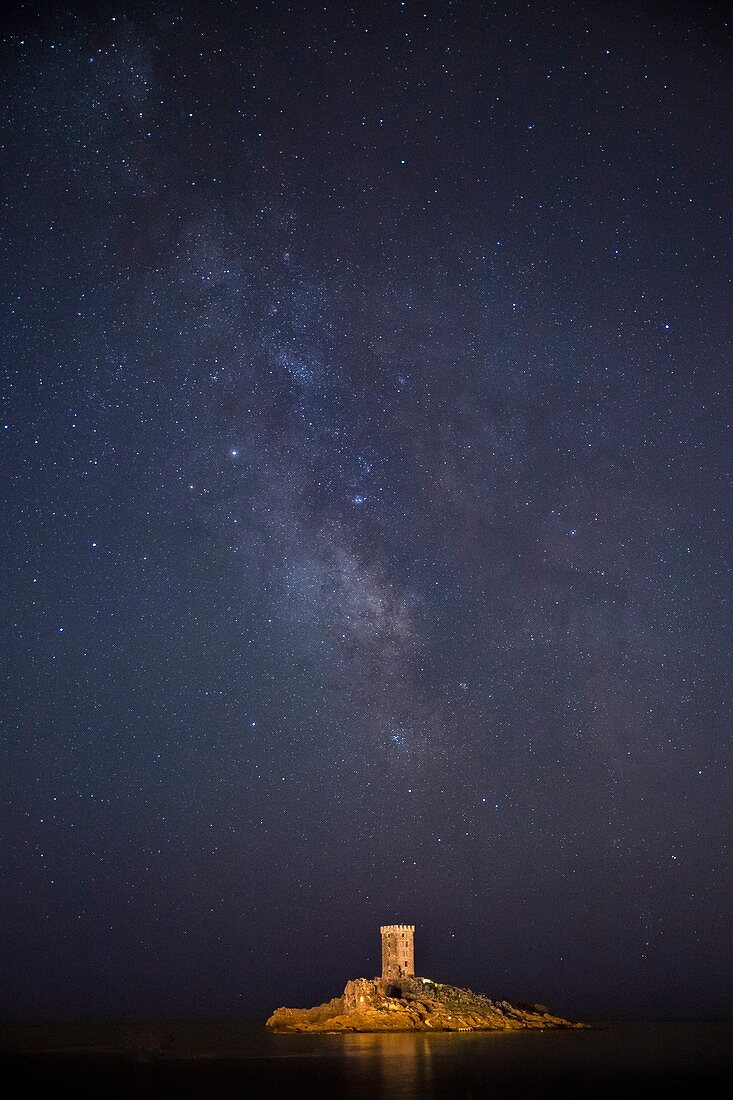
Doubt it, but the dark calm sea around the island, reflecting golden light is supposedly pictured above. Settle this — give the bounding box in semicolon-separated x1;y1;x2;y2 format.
0;1022;733;1100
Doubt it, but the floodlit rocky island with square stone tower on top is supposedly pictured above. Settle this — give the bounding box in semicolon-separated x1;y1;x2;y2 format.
267;924;586;1032
